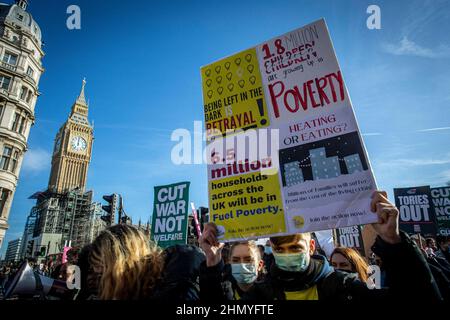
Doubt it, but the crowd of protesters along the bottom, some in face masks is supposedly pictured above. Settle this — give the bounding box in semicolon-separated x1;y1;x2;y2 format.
2;191;450;303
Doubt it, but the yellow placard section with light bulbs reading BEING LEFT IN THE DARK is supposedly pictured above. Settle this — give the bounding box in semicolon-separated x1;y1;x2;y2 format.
201;48;269;135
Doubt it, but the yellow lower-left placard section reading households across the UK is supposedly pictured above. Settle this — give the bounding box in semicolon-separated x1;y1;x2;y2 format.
209;172;286;240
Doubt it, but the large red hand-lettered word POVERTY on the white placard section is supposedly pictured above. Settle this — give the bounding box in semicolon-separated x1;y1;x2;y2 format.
269;71;345;118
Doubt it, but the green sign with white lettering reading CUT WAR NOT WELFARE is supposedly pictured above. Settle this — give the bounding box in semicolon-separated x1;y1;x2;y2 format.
152;181;190;248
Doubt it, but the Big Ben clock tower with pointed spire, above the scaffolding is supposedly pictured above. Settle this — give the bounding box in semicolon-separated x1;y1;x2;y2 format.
48;80;94;193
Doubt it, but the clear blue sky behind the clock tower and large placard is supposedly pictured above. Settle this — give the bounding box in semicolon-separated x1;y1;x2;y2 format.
2;0;450;252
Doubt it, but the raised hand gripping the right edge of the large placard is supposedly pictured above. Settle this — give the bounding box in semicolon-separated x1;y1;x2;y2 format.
370;191;401;244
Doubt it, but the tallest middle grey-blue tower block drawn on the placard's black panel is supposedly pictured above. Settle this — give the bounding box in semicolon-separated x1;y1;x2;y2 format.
309;148;341;180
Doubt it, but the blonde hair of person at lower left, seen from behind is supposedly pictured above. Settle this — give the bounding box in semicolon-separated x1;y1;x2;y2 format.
89;224;164;300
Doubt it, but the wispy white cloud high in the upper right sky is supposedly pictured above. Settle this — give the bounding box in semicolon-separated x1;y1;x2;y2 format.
383;36;450;58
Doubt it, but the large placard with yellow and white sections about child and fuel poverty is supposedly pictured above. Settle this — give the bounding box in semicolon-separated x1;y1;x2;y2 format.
201;19;376;241
